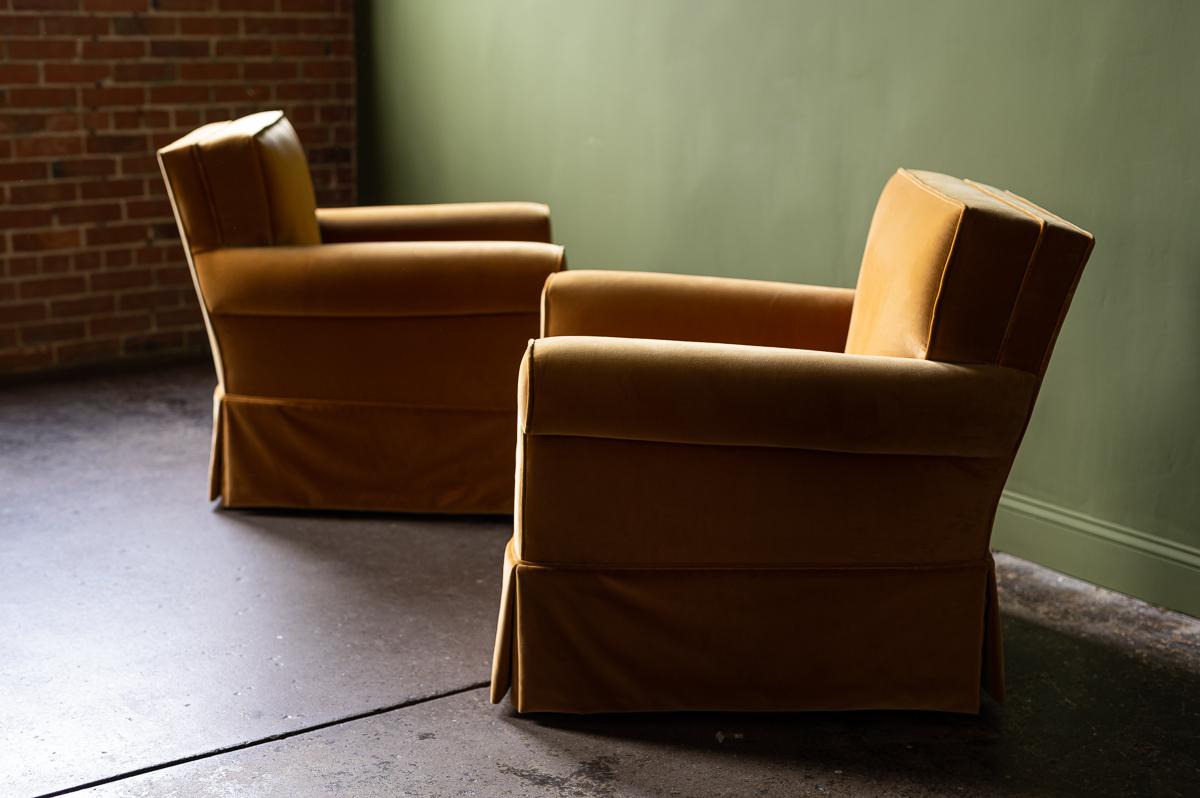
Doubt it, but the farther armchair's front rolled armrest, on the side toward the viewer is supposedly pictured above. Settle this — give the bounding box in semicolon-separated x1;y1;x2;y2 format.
194;241;563;317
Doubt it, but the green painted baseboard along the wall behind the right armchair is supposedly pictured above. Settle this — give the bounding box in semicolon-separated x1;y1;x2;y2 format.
991;491;1200;618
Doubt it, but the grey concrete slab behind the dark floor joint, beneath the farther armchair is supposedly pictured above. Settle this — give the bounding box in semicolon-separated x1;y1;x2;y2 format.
0;367;511;796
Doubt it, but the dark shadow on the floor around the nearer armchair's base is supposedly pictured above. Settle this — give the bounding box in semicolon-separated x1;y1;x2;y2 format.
500;609;1200;798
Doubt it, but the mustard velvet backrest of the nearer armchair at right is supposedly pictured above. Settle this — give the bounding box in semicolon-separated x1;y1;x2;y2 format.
846;169;1093;374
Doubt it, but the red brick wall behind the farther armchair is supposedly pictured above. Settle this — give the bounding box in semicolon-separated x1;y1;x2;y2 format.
0;0;355;373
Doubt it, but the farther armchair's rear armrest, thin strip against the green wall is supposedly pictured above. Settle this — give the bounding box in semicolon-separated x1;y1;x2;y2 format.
317;203;550;244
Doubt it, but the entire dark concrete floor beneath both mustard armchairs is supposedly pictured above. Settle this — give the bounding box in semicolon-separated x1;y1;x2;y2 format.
0;366;1200;798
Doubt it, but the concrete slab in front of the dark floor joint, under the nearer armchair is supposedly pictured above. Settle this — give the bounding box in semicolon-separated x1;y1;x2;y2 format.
85;557;1200;798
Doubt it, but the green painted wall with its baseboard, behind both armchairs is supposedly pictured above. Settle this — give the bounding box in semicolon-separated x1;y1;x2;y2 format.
360;0;1200;614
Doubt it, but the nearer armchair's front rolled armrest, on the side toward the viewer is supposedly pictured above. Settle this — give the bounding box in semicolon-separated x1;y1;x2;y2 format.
520;336;1036;457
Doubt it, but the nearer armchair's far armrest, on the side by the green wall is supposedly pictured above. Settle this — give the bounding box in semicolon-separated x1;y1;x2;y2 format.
541;271;854;352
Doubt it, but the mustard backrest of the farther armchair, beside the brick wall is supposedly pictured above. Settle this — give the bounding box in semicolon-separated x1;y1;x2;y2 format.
158;110;320;252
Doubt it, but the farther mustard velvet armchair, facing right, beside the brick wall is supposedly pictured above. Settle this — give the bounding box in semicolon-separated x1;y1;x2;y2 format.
158;112;563;512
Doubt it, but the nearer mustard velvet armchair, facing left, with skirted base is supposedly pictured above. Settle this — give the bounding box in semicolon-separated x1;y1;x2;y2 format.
492;170;1092;713
